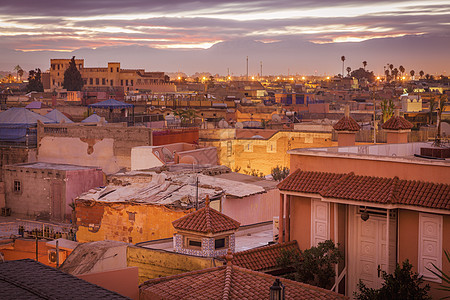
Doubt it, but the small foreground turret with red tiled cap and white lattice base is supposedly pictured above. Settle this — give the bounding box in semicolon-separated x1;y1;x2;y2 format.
172;196;240;257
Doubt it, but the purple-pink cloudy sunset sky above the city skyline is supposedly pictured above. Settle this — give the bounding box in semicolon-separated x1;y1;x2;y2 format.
0;0;450;75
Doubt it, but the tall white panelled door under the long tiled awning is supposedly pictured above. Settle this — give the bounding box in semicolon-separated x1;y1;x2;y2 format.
356;216;396;289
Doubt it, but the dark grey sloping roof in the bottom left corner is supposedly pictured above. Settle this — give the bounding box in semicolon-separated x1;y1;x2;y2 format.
0;259;128;299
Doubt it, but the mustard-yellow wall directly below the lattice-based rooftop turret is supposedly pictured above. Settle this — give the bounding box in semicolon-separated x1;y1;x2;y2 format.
127;246;223;283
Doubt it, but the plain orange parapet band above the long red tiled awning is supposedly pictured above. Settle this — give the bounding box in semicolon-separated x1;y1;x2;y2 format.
290;155;450;184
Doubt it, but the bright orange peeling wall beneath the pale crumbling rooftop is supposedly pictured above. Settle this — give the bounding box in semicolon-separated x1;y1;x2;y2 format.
76;202;190;243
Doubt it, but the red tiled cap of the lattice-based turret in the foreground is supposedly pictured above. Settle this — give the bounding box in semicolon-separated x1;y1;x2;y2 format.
172;205;240;233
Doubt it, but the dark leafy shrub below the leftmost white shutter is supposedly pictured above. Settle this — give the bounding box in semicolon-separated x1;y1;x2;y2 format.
278;240;343;289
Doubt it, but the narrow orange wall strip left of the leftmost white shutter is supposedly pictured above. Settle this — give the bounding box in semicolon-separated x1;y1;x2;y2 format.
291;196;311;250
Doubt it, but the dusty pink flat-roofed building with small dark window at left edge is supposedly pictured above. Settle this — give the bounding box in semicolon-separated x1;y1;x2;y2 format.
3;162;103;221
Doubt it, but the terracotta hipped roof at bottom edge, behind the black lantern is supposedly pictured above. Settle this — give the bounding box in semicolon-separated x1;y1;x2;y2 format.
139;265;346;300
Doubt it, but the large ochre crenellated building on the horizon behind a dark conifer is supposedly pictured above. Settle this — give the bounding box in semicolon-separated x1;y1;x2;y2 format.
50;59;176;92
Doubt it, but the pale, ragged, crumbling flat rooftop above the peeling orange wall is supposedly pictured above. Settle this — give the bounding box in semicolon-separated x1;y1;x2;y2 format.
78;170;265;208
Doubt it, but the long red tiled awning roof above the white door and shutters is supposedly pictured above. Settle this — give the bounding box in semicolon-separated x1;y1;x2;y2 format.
278;170;450;210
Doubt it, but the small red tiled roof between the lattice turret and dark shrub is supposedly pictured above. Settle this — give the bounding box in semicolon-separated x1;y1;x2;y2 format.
224;241;300;271
